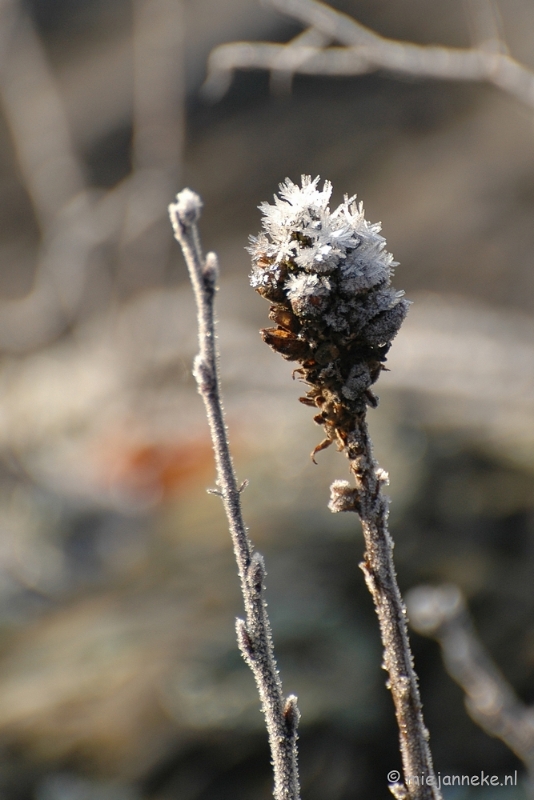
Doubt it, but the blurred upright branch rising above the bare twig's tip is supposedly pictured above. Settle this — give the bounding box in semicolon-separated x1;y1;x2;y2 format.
117;0;185;294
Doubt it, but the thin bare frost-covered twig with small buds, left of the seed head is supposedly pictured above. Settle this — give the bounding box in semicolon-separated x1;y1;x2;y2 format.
169;189;300;800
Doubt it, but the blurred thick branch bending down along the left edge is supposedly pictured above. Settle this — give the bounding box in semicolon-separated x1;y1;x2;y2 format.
0;0;107;350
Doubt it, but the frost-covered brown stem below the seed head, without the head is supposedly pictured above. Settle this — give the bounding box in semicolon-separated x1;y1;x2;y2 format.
336;413;440;800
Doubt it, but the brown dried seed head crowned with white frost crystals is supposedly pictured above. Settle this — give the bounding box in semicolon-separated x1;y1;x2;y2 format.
249;175;409;456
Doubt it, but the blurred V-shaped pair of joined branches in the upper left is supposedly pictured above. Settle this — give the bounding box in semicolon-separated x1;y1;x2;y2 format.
0;0;188;351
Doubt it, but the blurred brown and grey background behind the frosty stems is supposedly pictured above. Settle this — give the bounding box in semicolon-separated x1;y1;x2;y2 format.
0;0;534;800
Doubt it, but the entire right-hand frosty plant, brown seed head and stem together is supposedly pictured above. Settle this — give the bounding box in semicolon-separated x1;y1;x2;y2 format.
253;175;439;800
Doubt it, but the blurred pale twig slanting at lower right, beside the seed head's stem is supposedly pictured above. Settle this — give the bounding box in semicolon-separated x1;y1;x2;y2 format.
406;585;534;782
